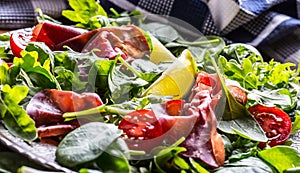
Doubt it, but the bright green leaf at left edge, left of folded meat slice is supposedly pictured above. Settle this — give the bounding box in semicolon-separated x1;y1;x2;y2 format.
0;85;37;141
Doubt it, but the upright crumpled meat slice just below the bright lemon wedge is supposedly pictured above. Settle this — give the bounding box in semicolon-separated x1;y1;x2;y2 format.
181;71;225;167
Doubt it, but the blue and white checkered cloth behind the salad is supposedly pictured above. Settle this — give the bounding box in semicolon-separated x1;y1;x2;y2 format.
0;0;300;64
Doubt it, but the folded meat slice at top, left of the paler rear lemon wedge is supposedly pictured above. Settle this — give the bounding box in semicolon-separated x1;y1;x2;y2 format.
55;25;150;59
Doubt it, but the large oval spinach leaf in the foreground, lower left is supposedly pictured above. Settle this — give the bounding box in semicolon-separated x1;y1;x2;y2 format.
56;122;122;167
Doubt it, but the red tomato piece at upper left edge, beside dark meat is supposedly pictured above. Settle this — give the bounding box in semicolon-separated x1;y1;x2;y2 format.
9;30;32;58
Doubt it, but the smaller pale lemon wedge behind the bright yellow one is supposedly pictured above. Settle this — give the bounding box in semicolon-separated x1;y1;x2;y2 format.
150;36;176;64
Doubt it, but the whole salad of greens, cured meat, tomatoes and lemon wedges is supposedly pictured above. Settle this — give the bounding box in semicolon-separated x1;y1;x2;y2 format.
0;0;300;173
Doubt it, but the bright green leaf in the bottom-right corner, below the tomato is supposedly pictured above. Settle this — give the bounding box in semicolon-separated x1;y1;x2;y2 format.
258;146;300;173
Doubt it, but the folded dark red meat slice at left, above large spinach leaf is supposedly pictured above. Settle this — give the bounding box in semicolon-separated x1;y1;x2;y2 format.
26;89;103;138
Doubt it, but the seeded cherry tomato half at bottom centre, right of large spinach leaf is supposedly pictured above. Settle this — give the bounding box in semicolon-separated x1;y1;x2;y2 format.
118;110;163;140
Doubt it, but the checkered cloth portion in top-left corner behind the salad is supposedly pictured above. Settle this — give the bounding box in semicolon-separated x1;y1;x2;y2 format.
0;0;67;30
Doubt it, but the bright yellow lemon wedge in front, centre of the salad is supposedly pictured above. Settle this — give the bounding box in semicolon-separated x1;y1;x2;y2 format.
144;49;197;99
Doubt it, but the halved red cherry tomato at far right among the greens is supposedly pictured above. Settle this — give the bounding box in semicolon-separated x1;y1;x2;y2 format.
248;105;292;147
